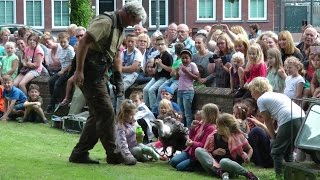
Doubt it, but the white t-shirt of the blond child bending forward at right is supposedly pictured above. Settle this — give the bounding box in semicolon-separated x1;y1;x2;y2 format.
257;92;305;127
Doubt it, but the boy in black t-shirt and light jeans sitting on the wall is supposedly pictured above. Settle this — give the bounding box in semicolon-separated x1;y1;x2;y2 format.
143;36;173;109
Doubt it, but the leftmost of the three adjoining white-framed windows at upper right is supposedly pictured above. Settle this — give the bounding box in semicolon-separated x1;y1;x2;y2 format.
197;0;216;20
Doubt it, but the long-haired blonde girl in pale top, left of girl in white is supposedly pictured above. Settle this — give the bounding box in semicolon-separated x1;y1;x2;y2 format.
267;48;287;93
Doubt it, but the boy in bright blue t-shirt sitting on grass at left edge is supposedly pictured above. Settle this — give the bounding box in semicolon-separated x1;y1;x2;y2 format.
0;75;27;121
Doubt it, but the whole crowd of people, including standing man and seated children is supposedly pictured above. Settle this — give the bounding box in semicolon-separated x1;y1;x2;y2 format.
0;2;320;179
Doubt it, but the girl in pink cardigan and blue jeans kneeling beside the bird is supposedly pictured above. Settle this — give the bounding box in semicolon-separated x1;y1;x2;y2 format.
170;103;219;171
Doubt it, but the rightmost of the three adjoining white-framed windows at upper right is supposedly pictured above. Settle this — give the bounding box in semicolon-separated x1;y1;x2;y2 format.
249;0;267;20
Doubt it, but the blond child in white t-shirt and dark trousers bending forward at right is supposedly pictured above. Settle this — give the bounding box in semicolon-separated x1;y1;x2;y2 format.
249;77;305;179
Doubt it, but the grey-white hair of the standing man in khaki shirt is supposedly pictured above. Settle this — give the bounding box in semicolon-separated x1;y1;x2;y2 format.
123;0;147;24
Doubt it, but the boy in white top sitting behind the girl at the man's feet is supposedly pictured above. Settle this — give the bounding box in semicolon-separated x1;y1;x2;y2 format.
130;91;156;144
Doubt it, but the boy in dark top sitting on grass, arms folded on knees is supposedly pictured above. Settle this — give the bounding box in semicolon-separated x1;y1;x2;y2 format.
22;84;48;124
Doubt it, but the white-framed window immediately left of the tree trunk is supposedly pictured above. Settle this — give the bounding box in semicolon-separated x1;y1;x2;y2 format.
52;0;70;28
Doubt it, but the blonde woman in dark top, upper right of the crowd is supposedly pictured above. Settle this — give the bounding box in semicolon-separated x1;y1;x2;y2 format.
278;31;303;62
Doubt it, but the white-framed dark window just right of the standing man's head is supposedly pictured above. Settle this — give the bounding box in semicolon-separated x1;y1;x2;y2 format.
149;0;168;27
